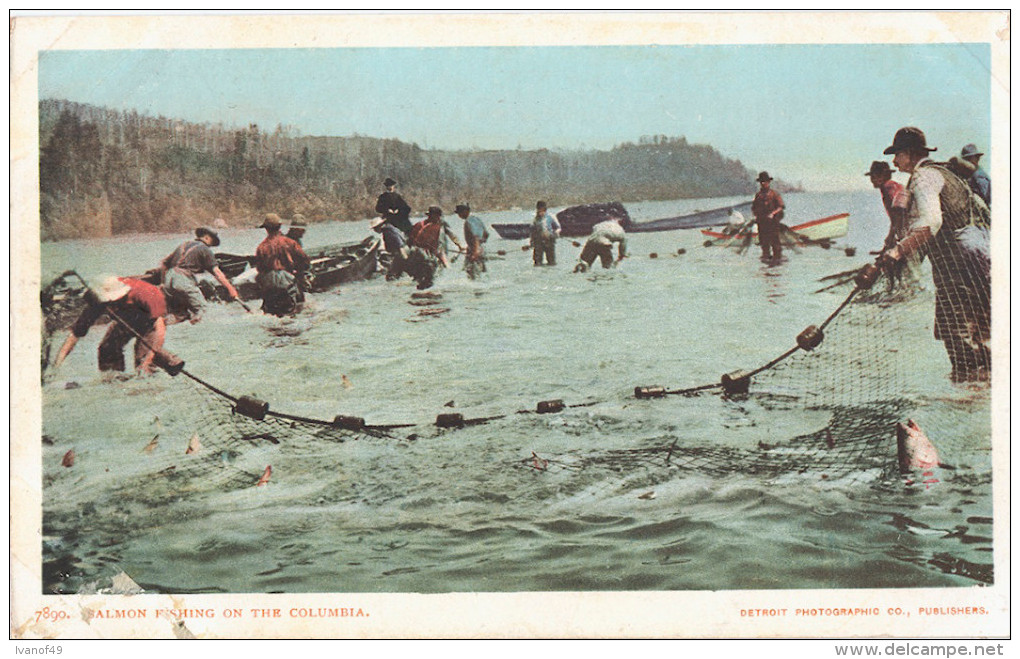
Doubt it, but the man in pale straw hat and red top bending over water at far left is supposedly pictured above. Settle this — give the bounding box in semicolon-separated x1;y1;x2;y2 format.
53;276;166;374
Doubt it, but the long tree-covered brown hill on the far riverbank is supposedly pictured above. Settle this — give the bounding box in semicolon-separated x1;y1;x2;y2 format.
39;100;791;240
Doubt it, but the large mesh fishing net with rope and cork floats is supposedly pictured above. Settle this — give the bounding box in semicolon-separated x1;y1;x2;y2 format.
43;178;990;507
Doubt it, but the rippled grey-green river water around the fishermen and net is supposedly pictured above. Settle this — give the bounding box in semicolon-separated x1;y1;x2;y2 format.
42;192;993;593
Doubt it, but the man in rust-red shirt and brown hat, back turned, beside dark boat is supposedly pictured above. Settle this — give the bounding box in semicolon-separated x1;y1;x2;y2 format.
255;213;310;316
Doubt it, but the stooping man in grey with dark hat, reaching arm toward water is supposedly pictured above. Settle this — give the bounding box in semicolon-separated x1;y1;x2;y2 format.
161;226;238;324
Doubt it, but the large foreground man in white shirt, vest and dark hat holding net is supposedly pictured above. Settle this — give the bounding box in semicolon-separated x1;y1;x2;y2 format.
876;126;991;382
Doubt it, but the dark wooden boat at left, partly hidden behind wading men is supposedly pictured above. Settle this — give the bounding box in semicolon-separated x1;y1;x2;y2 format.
207;236;381;300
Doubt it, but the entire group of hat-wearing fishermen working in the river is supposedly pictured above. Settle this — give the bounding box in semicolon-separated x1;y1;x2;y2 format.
45;126;991;382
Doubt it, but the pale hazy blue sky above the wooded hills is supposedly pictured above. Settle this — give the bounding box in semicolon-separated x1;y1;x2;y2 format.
39;44;990;189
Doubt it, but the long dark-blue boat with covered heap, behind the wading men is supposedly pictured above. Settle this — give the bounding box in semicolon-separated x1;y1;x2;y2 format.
493;201;751;240
